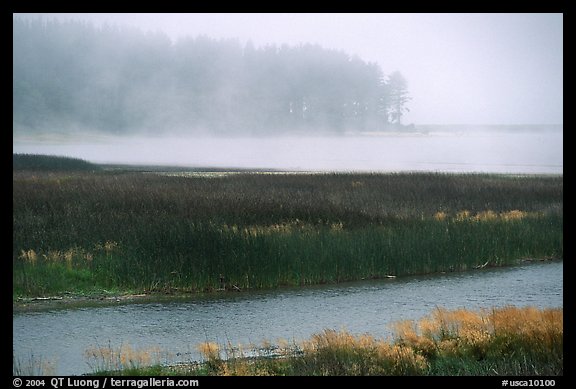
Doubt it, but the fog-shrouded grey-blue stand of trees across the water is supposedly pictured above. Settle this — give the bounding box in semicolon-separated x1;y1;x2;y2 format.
13;17;409;134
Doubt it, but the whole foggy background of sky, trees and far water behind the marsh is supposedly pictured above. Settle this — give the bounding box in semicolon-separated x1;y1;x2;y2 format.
13;14;563;174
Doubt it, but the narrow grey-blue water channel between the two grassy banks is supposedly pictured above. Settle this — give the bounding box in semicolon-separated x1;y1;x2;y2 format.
12;262;563;375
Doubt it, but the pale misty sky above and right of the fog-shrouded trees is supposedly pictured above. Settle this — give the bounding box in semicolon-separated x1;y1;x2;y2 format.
14;14;563;124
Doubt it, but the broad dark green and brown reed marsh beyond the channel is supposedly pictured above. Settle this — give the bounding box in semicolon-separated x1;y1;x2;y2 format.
13;156;563;296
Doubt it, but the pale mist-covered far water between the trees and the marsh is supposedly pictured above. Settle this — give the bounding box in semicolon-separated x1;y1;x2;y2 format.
13;129;563;174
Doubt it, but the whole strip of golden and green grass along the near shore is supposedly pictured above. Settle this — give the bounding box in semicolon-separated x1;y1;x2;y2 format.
90;307;564;376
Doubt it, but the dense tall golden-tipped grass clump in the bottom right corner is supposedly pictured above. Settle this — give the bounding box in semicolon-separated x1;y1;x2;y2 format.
290;307;563;375
